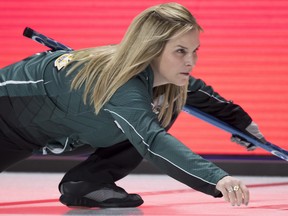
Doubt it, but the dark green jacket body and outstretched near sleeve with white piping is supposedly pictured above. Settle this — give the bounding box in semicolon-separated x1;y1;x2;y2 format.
0;51;251;197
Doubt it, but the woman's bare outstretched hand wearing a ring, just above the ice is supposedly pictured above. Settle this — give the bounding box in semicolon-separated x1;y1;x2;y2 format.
216;176;249;206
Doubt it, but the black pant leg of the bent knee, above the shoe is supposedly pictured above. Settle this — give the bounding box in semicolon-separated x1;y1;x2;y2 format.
60;140;142;184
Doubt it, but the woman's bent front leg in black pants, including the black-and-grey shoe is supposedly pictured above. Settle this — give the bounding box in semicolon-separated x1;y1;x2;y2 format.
59;141;143;208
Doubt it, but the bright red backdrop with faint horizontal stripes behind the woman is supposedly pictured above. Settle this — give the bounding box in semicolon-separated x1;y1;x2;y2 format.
0;0;288;175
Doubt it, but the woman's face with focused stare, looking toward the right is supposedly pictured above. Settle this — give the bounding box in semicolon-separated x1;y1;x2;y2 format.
151;29;200;87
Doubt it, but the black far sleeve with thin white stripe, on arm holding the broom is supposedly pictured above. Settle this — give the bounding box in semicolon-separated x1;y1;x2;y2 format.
186;77;252;131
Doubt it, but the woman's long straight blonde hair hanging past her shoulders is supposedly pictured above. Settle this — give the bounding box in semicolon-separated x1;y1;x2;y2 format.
69;3;202;127
